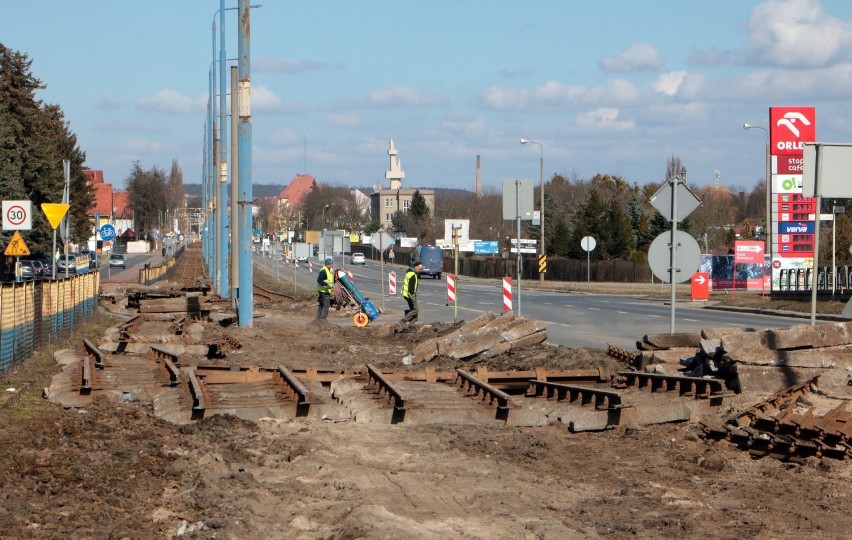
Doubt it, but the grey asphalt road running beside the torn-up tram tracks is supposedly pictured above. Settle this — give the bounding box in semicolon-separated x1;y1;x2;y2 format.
255;257;808;349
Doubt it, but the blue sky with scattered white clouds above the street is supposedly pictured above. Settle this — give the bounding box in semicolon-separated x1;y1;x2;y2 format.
5;0;852;190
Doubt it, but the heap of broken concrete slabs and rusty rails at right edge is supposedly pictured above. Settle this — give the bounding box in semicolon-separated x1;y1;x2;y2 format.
610;322;852;461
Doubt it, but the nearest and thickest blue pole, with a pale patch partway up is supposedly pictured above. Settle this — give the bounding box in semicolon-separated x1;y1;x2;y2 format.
237;0;254;328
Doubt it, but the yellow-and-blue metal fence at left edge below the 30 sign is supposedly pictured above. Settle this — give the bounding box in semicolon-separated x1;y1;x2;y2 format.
0;272;100;373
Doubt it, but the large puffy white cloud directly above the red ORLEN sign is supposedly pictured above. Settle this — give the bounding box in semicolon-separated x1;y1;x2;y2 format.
744;0;852;68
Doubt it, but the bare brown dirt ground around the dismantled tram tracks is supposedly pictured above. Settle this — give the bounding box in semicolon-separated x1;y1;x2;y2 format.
0;264;852;539
